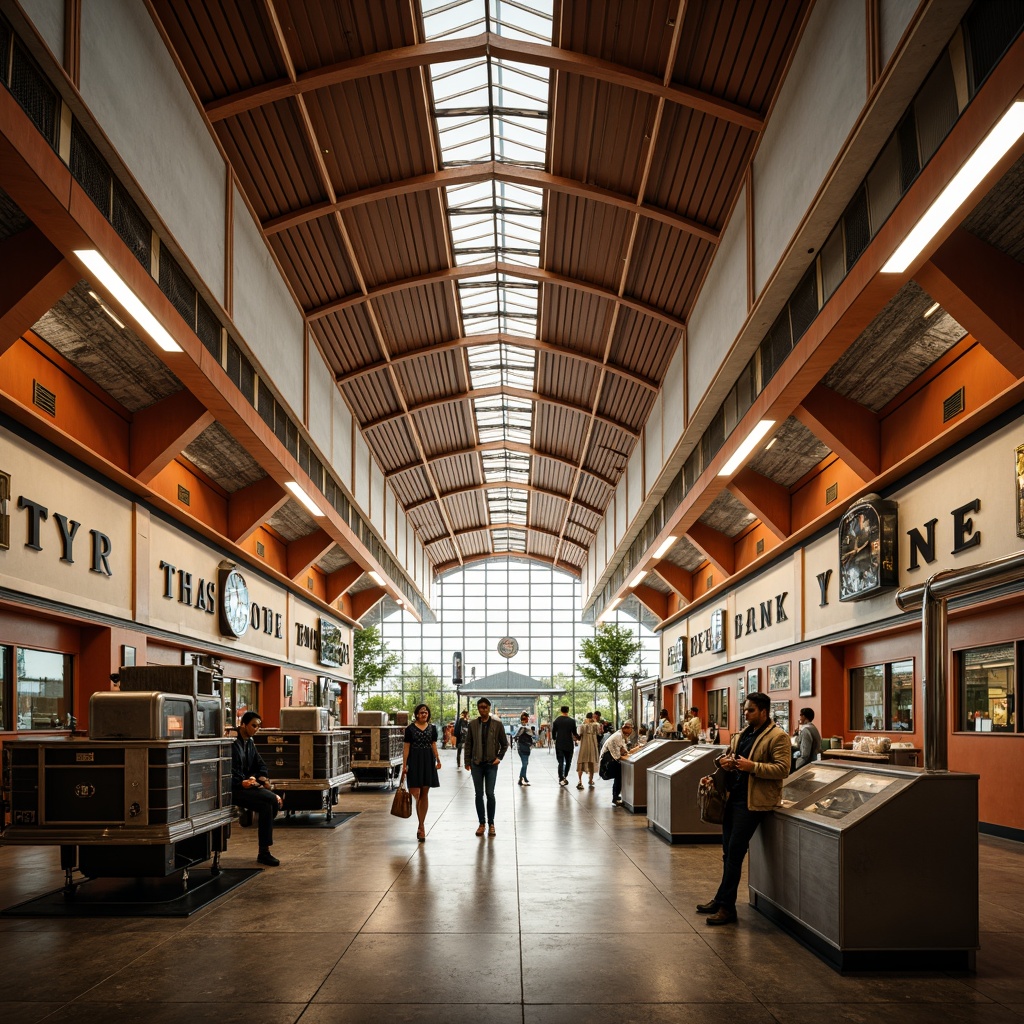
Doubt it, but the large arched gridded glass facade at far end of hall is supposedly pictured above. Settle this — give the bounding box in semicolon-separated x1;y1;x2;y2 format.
360;558;660;721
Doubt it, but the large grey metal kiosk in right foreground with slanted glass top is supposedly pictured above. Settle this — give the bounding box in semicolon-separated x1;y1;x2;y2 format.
749;762;978;971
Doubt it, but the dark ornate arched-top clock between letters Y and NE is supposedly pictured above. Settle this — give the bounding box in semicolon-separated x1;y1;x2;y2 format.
839;495;899;601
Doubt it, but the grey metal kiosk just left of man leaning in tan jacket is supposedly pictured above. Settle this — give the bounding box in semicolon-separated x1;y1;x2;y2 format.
647;743;726;843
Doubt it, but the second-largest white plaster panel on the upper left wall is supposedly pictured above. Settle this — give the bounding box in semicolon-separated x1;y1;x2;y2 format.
233;196;305;414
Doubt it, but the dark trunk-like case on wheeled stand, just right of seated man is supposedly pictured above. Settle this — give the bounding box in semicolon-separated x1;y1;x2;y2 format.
253;729;354;821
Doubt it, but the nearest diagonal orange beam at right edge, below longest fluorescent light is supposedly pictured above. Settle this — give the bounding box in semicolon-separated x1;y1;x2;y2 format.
914;227;1024;379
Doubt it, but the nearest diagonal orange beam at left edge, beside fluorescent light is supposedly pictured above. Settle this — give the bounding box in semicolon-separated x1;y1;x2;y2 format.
0;224;79;355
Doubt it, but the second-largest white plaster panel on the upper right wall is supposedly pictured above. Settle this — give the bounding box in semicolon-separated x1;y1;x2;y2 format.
684;188;746;411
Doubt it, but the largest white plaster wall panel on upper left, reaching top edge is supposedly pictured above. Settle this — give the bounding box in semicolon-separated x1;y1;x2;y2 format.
80;0;226;299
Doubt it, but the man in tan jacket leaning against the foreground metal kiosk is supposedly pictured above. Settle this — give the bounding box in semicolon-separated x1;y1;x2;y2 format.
697;692;792;925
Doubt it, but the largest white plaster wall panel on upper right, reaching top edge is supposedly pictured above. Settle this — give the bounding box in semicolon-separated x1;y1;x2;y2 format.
753;0;867;296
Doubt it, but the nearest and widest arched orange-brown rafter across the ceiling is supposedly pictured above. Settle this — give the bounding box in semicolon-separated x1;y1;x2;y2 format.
205;31;765;132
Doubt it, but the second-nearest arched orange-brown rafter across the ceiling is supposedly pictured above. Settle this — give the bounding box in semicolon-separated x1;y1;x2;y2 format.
263;161;722;245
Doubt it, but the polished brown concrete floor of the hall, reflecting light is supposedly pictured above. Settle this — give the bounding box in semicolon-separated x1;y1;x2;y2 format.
0;751;1024;1024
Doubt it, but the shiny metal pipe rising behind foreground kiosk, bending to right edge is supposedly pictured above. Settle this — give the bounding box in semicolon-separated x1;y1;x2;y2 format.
896;551;1024;771
